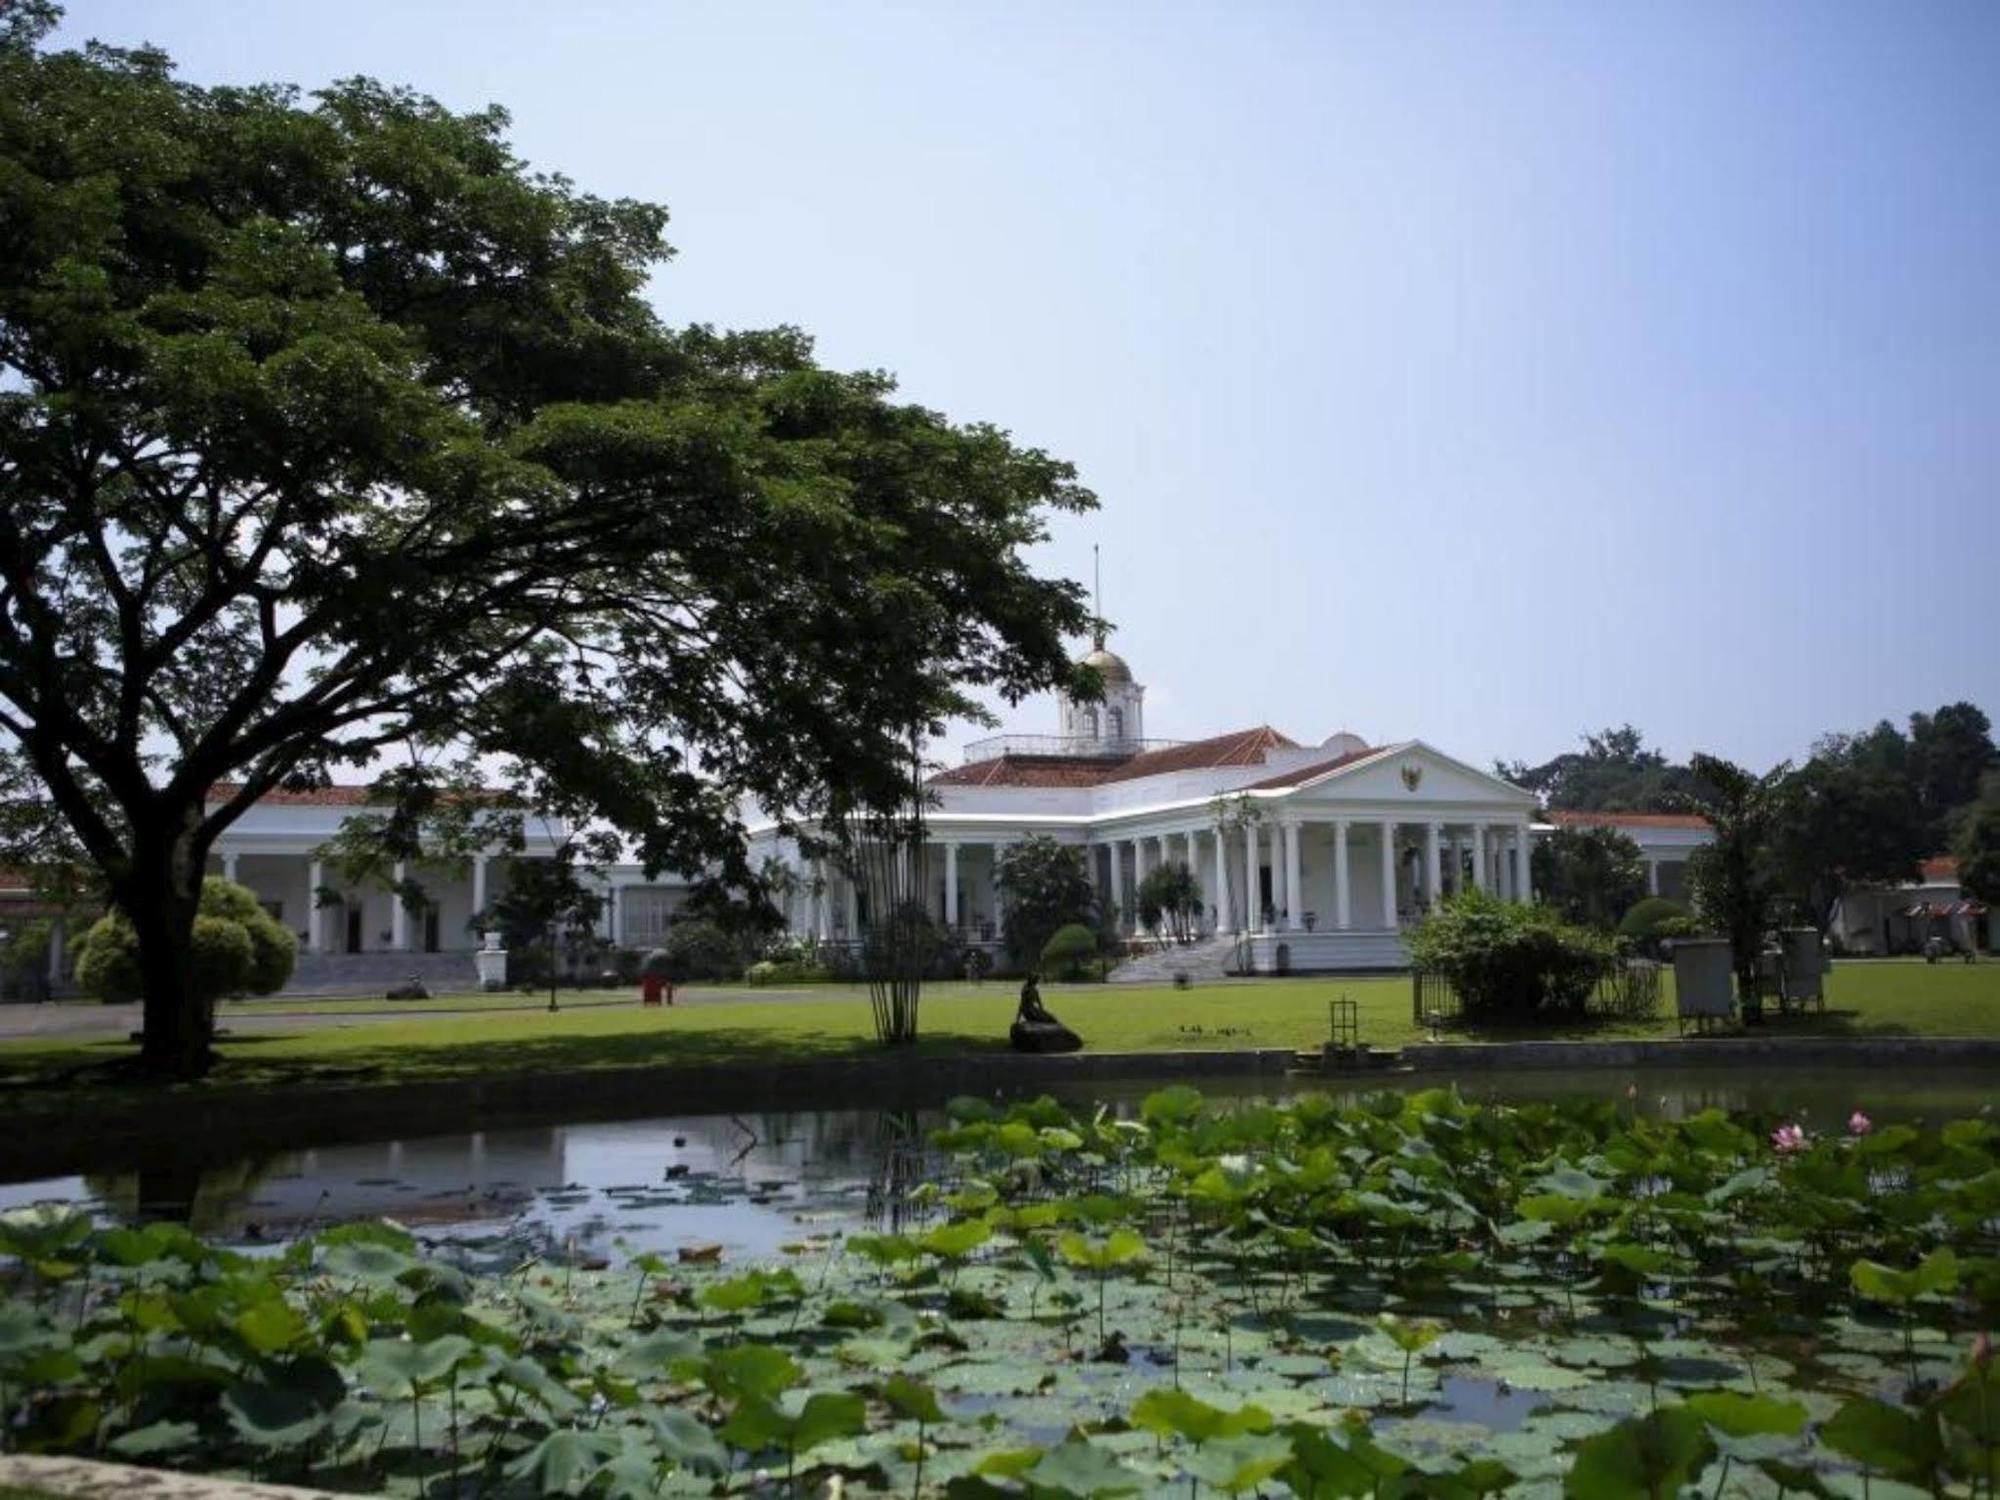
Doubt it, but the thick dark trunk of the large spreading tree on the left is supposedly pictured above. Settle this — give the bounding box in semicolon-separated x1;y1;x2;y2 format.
112;806;214;1078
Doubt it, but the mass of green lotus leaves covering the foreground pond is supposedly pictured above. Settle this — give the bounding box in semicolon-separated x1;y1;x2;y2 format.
0;1088;2000;1500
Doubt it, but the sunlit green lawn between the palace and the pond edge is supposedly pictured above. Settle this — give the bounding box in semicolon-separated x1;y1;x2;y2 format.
0;962;2000;1106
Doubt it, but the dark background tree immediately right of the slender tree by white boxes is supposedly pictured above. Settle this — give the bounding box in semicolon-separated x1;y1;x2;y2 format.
1770;720;1936;932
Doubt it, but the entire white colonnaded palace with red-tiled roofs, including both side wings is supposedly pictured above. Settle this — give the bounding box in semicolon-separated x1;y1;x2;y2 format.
0;640;1708;990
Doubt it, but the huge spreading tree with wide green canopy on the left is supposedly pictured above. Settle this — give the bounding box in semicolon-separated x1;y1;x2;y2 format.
0;0;1094;1074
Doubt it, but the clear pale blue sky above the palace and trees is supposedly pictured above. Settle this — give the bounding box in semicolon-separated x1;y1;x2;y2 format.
66;0;2000;766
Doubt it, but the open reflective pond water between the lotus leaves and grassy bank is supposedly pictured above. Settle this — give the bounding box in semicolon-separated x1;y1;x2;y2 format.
0;1068;2000;1258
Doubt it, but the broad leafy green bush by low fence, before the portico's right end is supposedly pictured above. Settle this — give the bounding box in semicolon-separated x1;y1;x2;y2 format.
1408;890;1618;1020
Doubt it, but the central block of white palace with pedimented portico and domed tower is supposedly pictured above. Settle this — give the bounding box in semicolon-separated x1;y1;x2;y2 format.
752;640;1706;972
